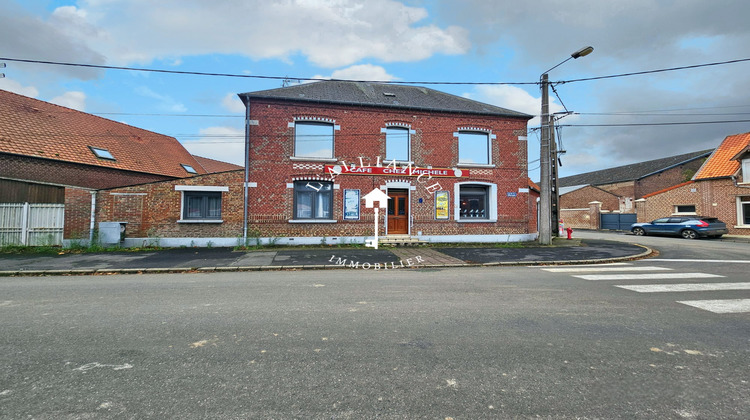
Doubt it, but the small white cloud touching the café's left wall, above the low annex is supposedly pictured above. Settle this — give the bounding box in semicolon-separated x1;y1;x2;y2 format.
182;127;245;166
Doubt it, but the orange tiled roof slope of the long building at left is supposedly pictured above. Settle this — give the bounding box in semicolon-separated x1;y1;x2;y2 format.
0;90;206;178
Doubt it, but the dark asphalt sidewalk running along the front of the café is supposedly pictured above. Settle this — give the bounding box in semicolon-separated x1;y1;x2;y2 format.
0;239;651;276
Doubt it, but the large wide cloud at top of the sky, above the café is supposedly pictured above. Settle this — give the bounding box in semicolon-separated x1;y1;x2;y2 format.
45;0;470;67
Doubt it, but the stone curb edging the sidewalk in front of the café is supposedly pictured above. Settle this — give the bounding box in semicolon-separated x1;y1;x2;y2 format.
0;244;655;277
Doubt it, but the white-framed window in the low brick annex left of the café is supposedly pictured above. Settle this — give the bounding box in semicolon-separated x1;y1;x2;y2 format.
174;185;229;223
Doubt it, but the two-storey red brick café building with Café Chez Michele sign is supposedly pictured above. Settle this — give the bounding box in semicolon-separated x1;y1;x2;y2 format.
234;81;536;244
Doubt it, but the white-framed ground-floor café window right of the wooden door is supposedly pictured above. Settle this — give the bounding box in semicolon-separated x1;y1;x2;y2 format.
453;182;497;222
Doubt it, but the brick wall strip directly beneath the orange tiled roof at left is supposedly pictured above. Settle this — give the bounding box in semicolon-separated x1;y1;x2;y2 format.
0;153;172;189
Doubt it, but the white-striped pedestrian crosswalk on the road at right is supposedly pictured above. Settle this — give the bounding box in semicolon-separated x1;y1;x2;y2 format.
542;263;750;314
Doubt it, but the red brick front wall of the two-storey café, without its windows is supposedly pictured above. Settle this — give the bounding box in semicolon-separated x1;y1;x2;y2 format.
244;101;536;240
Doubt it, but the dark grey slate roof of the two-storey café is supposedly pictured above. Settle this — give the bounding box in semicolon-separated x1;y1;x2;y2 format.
239;81;532;119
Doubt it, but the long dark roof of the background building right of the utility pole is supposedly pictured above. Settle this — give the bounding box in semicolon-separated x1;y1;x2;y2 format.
559;150;712;187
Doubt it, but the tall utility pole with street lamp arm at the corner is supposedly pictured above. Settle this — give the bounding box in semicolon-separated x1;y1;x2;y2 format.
539;46;594;245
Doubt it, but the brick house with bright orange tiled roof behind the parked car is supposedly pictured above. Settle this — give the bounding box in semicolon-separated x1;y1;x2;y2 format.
636;133;750;235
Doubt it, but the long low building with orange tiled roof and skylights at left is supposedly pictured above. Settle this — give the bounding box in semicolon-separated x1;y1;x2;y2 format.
0;90;240;245
